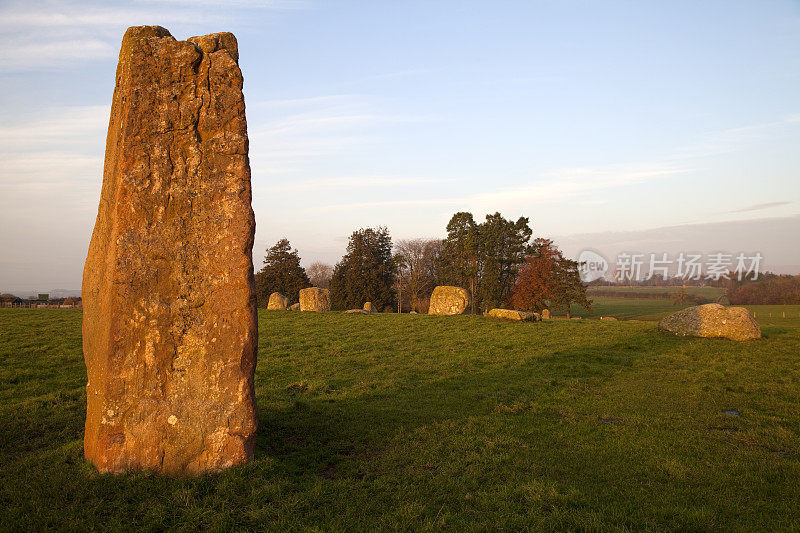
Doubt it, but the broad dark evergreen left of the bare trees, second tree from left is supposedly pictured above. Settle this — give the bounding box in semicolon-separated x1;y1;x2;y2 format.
330;227;395;310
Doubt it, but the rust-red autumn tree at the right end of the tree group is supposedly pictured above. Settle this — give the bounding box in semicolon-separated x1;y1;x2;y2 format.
509;238;592;314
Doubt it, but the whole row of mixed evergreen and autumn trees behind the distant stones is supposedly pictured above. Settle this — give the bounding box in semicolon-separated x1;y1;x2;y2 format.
256;212;591;313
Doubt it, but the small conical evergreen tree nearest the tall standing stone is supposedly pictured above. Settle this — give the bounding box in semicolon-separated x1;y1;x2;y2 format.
256;239;311;307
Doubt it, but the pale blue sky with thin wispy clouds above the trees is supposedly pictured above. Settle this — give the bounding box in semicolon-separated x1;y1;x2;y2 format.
0;0;800;293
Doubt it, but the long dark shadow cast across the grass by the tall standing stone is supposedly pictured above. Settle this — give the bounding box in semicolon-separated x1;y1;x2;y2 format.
256;325;668;476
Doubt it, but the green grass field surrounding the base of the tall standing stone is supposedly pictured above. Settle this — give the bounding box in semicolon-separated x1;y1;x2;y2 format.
0;310;800;531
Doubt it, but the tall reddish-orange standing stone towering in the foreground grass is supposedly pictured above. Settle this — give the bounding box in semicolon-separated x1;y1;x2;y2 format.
83;26;258;475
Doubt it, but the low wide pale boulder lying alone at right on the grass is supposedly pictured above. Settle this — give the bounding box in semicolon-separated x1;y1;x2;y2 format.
658;304;761;341
